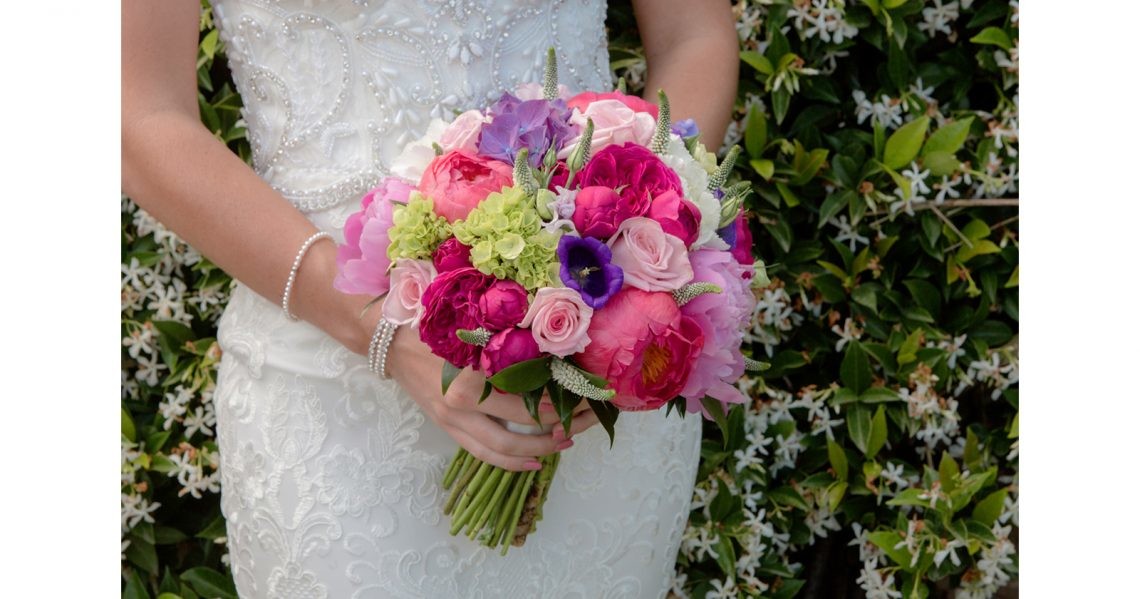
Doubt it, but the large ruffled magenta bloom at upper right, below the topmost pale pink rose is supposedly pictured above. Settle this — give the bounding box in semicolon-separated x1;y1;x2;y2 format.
576;143;684;213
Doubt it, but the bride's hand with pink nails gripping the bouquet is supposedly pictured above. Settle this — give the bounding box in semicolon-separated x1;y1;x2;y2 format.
389;326;597;471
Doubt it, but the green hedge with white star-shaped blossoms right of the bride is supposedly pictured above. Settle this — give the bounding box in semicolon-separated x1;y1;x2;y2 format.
610;0;1018;598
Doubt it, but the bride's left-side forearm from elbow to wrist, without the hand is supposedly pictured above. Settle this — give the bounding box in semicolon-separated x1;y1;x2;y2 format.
122;110;377;353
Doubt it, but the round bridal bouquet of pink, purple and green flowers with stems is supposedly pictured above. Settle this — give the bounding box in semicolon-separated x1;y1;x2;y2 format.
336;51;764;553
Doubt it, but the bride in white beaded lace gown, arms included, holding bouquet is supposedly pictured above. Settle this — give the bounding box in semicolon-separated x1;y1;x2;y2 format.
122;0;738;598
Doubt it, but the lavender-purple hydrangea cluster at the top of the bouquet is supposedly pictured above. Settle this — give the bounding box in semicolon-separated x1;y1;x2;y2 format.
479;94;578;169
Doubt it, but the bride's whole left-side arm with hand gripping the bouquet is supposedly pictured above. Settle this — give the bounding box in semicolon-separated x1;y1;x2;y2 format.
122;0;570;470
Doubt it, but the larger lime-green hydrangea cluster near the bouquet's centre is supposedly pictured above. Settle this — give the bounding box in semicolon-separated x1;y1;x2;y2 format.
453;187;559;291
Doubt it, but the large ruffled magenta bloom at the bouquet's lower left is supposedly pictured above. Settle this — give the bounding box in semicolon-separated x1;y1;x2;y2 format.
420;268;495;369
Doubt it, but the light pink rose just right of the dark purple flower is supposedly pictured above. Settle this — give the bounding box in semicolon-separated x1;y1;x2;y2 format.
608;217;693;291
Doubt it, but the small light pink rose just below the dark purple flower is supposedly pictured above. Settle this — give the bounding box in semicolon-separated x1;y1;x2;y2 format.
520;288;594;357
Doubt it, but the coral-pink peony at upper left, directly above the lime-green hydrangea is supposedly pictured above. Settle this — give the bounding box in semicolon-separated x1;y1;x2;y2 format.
418;149;512;222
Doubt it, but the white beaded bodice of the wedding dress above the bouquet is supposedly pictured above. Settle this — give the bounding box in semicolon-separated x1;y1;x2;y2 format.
213;0;612;214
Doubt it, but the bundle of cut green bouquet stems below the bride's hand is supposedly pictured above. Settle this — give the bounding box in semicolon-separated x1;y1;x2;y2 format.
443;447;559;555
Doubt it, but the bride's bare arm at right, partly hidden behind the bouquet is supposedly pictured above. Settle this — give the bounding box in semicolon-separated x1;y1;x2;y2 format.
633;0;740;151
